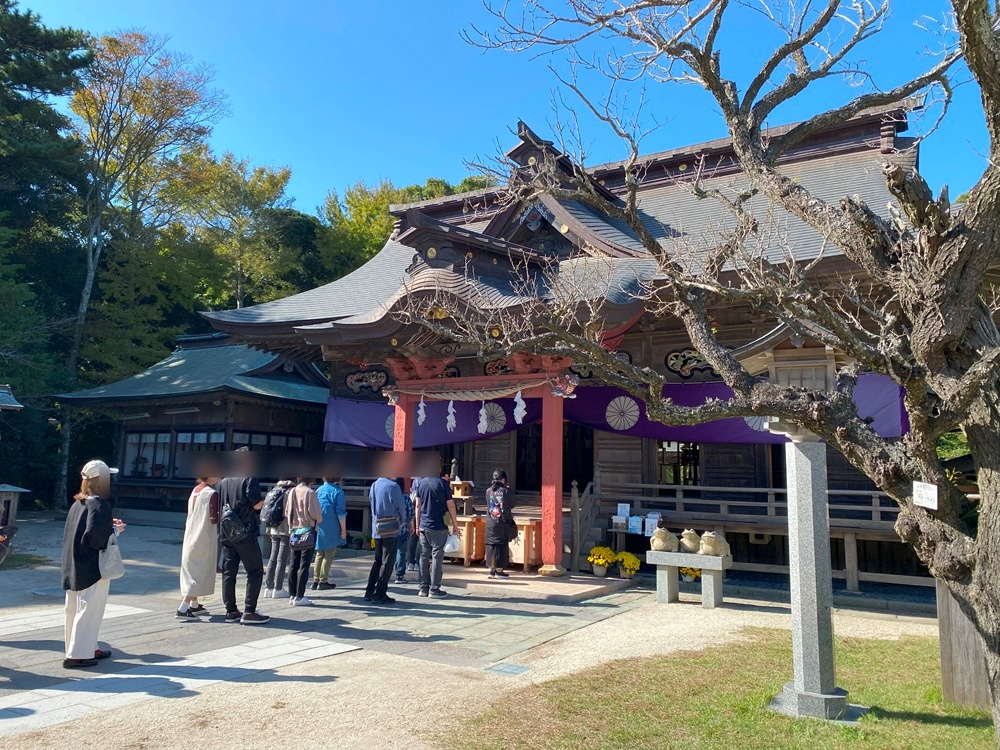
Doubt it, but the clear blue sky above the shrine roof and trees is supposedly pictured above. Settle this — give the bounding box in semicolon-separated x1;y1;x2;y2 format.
20;0;986;213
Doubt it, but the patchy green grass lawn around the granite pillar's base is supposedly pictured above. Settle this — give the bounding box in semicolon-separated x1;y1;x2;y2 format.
450;629;997;750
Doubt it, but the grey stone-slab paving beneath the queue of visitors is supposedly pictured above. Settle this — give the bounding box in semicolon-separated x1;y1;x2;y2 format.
0;518;651;736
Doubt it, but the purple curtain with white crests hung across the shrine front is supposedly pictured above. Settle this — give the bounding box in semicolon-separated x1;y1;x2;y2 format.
323;374;908;448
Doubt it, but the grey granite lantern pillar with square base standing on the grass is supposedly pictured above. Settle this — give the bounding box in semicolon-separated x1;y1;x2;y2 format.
773;432;848;719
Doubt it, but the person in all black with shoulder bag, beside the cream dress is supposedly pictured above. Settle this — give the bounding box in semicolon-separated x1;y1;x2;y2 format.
215;477;271;625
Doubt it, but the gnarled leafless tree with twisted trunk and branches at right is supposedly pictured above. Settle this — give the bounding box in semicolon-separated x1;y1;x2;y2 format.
404;0;1000;726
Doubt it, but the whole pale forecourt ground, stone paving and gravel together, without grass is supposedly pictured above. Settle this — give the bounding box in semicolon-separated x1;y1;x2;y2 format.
0;515;936;750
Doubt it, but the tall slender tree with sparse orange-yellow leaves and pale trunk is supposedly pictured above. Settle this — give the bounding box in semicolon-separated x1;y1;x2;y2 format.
57;31;226;506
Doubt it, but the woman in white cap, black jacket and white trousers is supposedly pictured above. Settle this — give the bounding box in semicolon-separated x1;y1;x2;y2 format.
62;460;125;669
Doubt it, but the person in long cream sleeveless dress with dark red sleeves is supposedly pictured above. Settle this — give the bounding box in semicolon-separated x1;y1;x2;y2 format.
176;477;219;620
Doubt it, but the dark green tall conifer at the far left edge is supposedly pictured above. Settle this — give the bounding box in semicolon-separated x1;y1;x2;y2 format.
0;0;91;506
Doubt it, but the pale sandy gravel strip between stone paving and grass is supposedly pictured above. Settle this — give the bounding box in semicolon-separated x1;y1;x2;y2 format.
10;595;937;750
